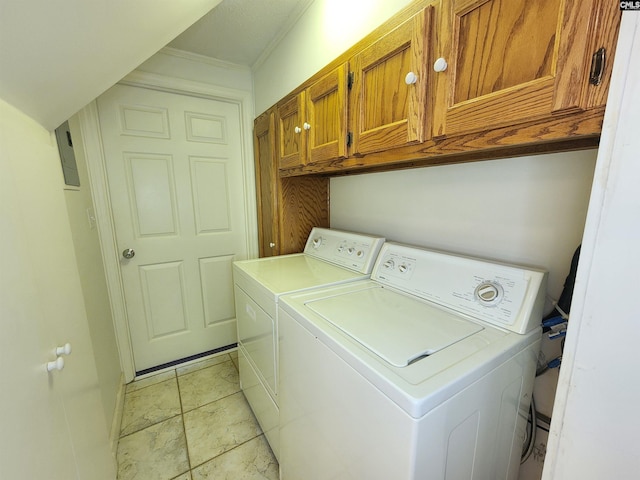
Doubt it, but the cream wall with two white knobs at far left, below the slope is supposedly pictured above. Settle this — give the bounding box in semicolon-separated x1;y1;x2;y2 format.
0;99;116;480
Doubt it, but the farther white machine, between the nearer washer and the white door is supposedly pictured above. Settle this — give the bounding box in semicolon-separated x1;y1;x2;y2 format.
233;228;384;457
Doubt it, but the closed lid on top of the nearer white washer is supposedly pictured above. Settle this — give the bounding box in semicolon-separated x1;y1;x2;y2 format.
306;286;483;367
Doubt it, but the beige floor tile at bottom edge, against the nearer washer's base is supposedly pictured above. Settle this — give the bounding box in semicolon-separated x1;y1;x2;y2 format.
191;435;279;480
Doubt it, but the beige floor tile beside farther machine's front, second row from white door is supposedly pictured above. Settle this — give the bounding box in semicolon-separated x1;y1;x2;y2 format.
178;361;240;412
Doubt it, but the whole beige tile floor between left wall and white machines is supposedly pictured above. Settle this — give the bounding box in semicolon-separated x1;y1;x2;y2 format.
117;351;278;480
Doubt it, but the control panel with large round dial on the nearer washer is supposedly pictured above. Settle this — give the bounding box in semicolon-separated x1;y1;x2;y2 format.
371;243;547;333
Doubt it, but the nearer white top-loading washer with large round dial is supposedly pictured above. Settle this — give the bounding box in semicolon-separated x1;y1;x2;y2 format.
278;243;547;480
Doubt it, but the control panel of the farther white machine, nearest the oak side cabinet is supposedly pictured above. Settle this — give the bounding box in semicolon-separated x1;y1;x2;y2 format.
304;227;384;274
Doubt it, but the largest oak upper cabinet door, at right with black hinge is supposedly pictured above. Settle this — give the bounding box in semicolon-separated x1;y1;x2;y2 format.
433;0;615;137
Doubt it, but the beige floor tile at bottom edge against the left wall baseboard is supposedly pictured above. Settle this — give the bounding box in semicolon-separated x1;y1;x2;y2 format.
117;417;189;480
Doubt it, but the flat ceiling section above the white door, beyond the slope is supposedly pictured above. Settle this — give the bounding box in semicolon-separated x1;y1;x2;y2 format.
169;0;313;66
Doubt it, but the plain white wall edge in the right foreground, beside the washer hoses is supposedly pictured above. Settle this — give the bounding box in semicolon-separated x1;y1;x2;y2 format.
543;12;640;480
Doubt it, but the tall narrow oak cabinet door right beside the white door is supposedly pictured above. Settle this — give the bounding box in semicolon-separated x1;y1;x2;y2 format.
253;109;280;257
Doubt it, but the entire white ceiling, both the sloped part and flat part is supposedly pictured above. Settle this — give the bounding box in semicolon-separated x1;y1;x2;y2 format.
0;0;313;130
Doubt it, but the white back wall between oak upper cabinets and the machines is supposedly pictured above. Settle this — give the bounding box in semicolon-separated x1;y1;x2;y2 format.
331;150;596;299
